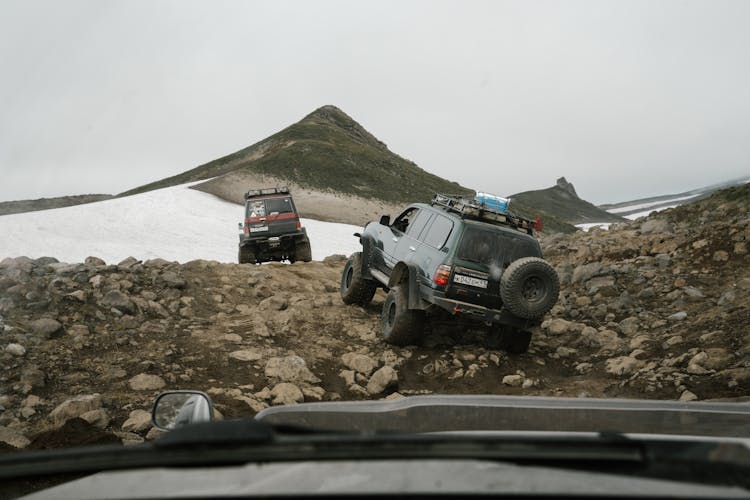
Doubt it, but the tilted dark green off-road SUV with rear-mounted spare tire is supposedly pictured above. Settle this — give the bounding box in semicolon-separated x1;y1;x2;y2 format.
341;195;560;353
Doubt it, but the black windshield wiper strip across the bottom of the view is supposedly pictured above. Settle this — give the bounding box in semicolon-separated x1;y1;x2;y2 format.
0;420;750;488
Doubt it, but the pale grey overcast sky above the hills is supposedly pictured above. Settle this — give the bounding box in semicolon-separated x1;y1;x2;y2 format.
0;0;750;203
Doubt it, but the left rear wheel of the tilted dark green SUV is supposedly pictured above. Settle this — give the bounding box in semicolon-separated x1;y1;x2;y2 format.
380;283;424;346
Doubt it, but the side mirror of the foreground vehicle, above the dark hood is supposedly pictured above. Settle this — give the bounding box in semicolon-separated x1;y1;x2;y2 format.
151;391;214;431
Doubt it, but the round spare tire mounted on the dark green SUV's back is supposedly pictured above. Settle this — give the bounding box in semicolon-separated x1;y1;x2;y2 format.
500;257;560;319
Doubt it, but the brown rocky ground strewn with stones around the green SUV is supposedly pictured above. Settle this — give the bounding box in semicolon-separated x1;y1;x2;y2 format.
0;187;750;449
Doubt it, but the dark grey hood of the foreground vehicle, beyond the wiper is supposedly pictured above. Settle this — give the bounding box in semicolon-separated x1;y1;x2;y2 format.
255;396;750;438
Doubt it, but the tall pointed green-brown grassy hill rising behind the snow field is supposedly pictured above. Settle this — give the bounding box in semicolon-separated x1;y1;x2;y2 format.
122;106;471;203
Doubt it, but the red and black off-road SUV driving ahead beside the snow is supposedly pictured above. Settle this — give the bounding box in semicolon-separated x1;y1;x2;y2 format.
238;187;312;264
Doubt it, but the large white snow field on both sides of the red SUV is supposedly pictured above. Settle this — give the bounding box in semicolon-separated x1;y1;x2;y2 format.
0;184;362;264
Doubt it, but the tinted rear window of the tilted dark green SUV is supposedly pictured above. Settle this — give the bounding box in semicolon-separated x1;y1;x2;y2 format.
456;226;542;267
